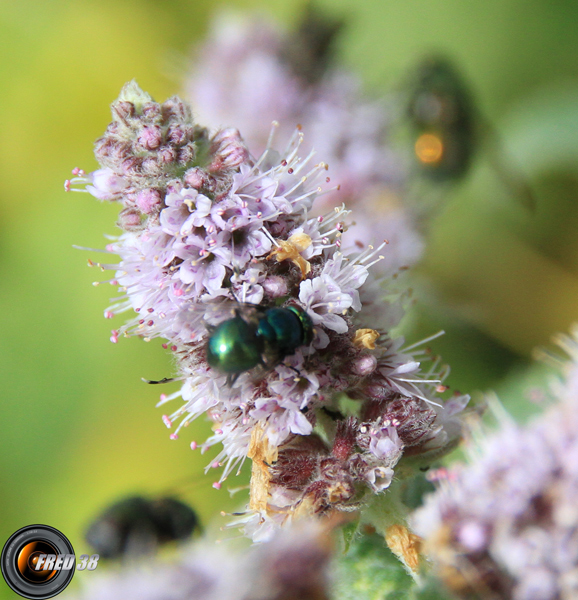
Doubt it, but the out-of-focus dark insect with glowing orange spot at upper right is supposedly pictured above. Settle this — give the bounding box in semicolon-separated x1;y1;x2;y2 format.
407;56;535;209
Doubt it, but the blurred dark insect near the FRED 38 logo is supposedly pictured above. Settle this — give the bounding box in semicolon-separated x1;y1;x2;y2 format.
85;496;200;559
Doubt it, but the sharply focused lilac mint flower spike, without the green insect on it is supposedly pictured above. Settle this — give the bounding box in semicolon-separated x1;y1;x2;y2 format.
67;82;468;540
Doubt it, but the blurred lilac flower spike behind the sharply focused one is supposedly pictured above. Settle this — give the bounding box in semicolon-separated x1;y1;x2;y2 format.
186;9;424;276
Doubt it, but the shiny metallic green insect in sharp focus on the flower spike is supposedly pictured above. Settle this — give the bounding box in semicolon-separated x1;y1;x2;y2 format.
207;304;313;381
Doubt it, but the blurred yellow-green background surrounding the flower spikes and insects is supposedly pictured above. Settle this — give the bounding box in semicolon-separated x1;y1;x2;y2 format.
0;0;578;598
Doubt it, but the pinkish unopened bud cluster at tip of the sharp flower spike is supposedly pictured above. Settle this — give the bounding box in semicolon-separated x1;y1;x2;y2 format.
67;82;247;231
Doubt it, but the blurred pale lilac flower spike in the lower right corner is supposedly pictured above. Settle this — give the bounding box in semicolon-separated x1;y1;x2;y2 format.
413;327;578;600
